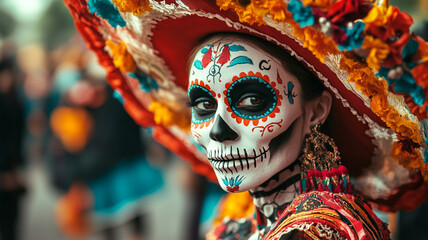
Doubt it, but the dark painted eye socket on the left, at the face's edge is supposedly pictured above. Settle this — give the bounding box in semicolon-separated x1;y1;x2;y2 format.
188;85;217;124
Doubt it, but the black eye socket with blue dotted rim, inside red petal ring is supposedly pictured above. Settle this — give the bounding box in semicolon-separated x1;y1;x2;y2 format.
227;76;277;119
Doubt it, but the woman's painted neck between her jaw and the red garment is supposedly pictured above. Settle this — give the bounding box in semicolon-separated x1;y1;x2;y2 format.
249;161;300;226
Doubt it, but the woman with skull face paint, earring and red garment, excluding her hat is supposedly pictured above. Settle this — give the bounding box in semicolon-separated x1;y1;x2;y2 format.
188;34;388;239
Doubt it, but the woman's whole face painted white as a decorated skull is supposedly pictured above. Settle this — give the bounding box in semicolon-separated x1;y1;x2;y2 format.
188;38;304;192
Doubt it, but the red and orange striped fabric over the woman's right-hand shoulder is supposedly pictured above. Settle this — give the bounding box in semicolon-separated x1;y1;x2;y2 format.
265;191;390;240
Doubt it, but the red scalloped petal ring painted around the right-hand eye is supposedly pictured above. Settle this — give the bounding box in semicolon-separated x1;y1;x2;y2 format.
223;71;283;126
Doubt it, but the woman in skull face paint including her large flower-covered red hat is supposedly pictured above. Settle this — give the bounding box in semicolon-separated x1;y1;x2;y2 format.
66;0;428;239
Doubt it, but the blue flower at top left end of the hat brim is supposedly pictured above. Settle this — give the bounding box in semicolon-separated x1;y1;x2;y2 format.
88;0;126;28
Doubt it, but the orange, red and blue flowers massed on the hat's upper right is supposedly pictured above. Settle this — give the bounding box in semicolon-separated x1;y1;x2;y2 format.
217;0;428;178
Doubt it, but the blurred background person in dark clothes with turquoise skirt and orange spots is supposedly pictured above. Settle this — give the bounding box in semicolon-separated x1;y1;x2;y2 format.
50;46;163;239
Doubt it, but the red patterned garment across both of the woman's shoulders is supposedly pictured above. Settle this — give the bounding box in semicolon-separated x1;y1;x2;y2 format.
207;191;390;240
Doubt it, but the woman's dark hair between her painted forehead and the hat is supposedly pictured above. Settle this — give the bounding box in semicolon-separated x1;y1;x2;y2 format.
188;33;325;100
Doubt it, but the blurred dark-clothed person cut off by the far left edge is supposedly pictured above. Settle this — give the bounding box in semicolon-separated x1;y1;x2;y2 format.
0;42;25;240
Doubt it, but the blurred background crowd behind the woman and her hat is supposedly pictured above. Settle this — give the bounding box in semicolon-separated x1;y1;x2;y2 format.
0;0;428;240
